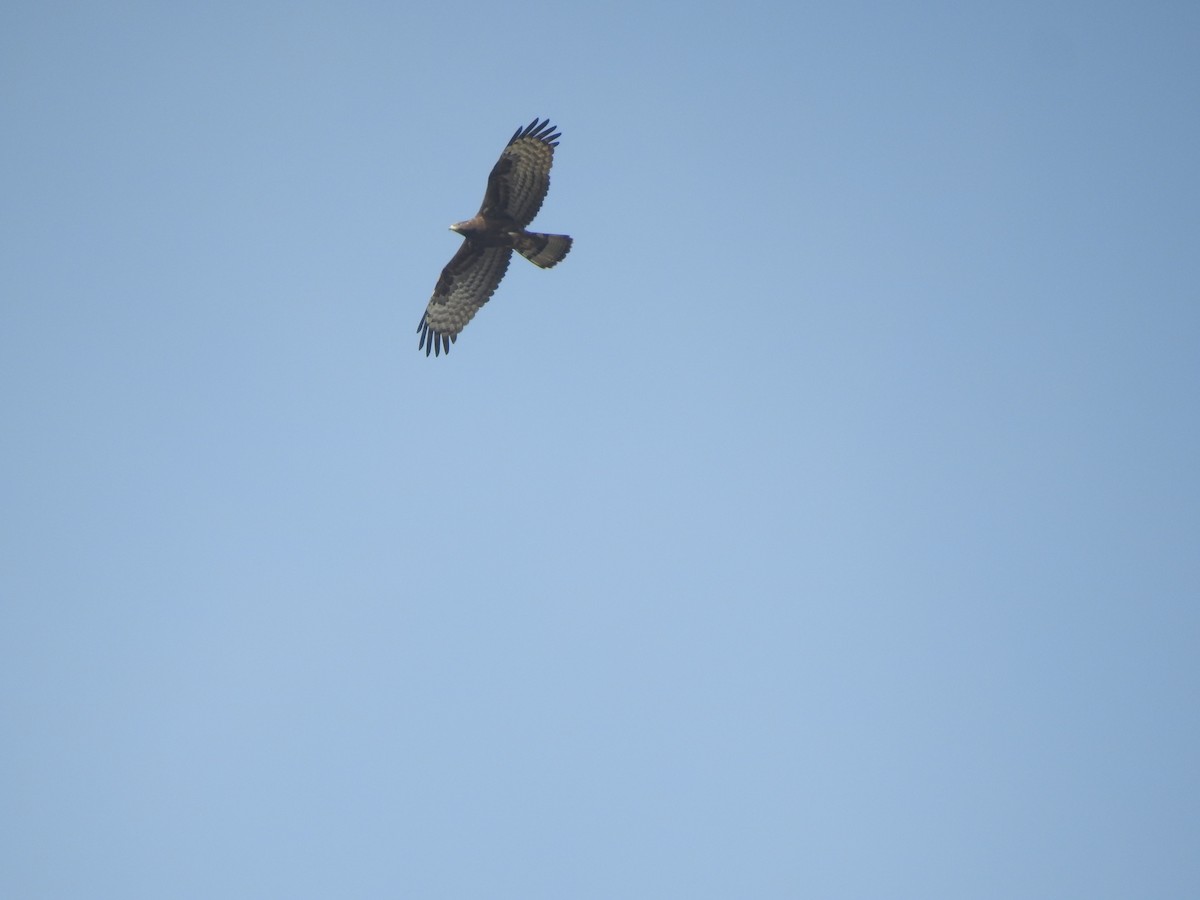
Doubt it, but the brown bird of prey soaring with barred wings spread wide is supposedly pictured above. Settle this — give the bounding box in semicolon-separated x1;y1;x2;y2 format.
416;119;571;356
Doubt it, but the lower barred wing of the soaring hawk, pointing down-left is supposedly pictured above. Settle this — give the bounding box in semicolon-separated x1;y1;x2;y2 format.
416;248;512;356
